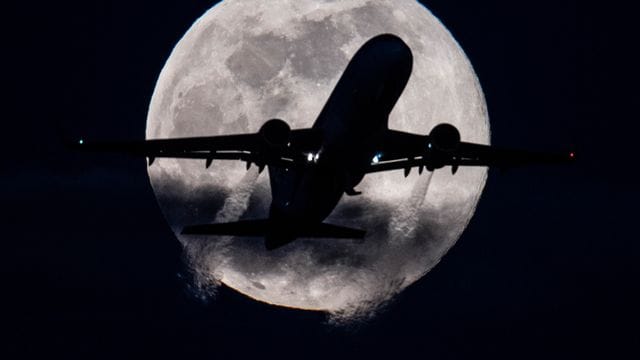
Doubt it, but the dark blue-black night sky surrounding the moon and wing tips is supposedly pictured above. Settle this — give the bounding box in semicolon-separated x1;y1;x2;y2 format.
0;0;640;359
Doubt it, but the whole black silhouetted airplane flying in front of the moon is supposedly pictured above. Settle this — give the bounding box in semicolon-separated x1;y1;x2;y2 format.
75;34;575;250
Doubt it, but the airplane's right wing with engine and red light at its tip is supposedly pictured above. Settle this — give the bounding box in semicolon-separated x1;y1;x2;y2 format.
365;124;575;176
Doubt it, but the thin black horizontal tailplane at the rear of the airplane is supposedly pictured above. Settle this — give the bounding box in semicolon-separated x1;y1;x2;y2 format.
182;219;366;250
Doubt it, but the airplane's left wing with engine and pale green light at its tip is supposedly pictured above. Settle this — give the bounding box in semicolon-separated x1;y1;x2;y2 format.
74;119;320;168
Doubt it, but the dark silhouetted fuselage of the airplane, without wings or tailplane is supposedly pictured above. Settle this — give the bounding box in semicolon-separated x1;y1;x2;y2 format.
266;34;413;247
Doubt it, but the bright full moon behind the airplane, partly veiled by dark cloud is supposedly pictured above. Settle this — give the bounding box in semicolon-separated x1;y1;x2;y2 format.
146;0;490;319
